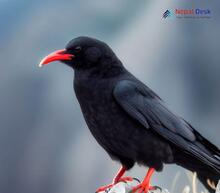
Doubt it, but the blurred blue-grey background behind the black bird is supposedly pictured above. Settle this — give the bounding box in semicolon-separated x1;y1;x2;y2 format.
0;0;220;193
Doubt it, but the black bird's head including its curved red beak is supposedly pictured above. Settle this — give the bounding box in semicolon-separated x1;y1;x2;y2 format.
39;37;121;70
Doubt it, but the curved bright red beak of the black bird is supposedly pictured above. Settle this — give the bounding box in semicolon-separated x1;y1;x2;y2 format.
39;49;74;67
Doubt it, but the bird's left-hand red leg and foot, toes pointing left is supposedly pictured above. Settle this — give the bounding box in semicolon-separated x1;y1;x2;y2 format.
96;166;133;192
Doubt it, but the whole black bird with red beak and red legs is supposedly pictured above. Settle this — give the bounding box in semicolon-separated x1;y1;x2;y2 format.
40;37;220;193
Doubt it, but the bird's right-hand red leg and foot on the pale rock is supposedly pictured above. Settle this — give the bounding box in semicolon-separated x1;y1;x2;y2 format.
132;168;155;193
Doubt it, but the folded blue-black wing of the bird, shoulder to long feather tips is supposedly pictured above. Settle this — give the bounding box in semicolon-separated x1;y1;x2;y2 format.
113;80;219;171
